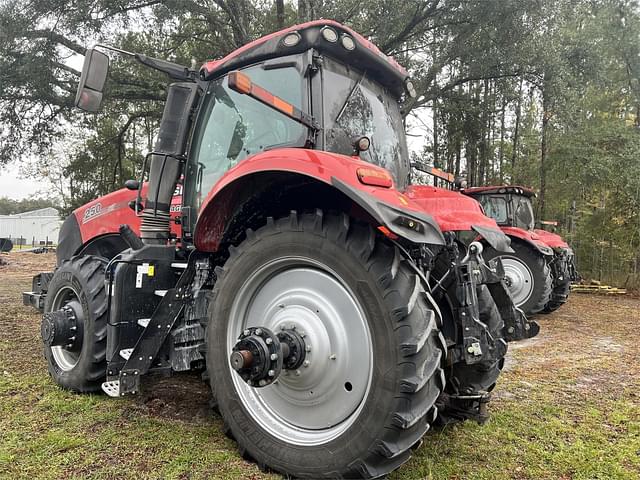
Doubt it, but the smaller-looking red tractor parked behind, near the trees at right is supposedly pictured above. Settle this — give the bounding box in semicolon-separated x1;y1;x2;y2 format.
463;186;578;313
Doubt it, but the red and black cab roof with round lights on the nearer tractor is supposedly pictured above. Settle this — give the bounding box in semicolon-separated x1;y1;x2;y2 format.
200;20;409;96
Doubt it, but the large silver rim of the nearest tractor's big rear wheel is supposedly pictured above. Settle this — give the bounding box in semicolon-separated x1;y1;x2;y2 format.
227;257;373;445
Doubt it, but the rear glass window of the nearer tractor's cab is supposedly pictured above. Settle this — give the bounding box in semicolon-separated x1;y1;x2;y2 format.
322;58;410;189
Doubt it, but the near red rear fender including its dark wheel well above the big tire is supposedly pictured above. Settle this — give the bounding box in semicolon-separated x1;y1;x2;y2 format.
194;148;444;252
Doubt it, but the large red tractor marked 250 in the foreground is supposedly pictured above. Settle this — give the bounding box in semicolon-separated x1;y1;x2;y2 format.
24;21;538;478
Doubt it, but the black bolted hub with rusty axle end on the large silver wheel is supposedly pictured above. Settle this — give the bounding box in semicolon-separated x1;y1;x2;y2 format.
229;327;306;387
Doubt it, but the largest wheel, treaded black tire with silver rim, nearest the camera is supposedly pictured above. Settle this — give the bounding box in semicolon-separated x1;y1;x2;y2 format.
207;211;445;478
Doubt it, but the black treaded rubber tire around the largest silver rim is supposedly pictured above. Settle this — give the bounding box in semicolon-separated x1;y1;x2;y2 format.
206;211;446;478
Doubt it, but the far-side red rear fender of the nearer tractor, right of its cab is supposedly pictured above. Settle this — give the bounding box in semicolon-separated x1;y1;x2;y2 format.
404;185;513;253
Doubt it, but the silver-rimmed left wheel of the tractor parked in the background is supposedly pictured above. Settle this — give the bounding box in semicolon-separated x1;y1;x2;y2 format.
482;242;553;315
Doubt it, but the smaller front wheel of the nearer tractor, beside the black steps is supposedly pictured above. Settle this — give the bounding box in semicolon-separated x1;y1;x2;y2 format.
44;255;107;392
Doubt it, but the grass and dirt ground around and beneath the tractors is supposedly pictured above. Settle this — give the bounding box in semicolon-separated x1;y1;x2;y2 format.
0;252;640;479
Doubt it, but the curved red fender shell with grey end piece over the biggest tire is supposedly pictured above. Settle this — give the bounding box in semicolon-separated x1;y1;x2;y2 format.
194;148;444;252
